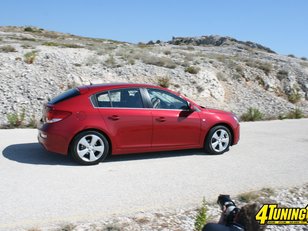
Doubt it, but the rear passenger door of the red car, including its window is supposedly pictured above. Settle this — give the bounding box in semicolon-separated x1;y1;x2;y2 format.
96;88;152;150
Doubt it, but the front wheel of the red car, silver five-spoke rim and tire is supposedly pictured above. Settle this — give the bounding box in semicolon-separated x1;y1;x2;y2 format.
204;125;232;155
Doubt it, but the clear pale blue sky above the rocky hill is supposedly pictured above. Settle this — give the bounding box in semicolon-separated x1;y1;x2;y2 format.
0;0;308;57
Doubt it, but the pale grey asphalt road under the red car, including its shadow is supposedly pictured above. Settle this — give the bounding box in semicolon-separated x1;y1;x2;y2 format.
0;119;308;230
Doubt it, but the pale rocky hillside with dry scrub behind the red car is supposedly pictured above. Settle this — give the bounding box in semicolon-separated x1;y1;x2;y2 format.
0;27;308;125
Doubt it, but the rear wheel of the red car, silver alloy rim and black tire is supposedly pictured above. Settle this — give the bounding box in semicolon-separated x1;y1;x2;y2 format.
70;131;109;165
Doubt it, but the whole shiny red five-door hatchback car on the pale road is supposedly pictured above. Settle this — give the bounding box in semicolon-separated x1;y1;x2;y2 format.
38;84;240;165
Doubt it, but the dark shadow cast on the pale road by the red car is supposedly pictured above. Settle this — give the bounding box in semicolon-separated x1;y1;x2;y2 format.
2;143;205;166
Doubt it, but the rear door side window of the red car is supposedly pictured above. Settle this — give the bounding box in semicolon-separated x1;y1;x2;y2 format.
97;88;143;108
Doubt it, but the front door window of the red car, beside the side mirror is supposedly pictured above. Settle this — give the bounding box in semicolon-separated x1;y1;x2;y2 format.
148;89;188;110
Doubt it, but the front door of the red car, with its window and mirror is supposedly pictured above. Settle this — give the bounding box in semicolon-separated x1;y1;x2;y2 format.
147;88;201;148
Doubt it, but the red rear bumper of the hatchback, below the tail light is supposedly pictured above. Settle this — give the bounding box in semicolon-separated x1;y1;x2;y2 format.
37;125;69;155
